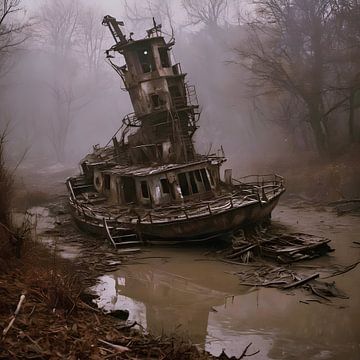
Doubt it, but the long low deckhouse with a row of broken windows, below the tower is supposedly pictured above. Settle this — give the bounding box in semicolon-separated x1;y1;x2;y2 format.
93;161;220;207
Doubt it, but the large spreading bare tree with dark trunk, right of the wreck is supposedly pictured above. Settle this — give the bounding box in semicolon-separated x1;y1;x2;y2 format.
237;0;356;155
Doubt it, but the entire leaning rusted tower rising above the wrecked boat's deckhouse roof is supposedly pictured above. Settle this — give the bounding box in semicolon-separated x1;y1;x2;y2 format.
103;15;200;164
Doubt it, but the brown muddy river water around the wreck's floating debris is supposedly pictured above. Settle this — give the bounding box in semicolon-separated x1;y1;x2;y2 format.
96;206;360;360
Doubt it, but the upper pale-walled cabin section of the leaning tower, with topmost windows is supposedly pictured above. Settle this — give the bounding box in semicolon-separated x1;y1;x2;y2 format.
103;16;198;119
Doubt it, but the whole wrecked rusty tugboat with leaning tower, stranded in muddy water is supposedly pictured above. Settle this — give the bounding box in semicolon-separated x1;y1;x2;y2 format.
66;16;285;246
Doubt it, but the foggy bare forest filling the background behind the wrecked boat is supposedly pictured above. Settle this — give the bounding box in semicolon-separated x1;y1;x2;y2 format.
0;0;360;171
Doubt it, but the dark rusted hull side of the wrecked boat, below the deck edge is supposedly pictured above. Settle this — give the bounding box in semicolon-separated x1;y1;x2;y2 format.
68;192;282;244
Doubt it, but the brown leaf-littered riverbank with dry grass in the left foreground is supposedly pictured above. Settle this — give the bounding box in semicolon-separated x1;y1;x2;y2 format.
0;217;222;359
